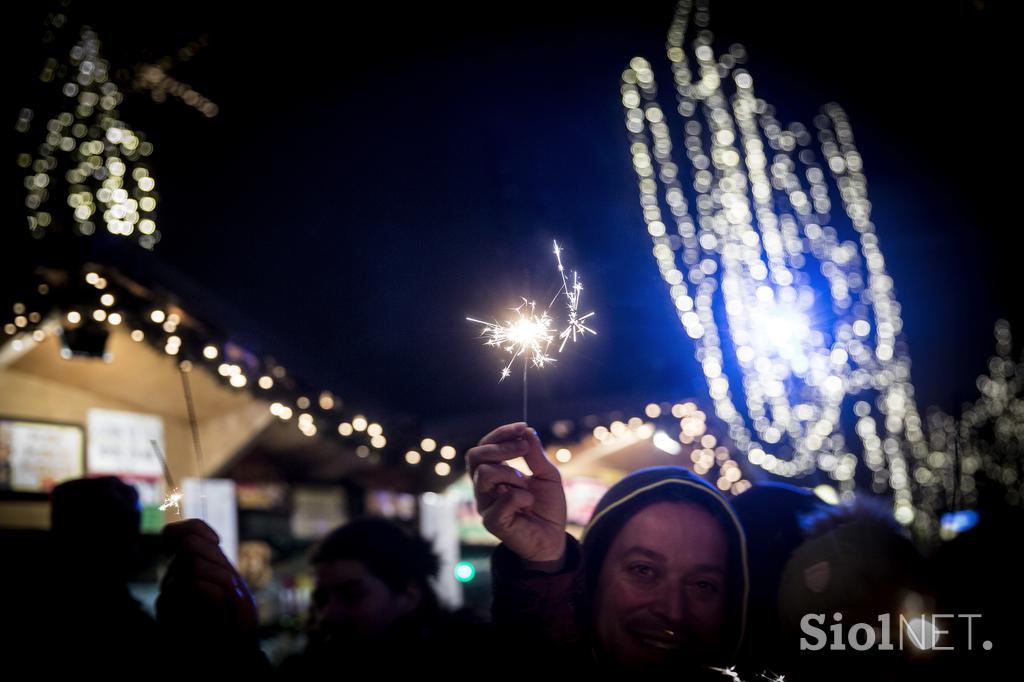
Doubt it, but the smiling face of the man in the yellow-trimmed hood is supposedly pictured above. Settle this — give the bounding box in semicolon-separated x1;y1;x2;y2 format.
594;502;728;668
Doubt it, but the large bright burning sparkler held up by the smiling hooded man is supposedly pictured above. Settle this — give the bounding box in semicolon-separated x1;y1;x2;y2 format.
466;242;597;421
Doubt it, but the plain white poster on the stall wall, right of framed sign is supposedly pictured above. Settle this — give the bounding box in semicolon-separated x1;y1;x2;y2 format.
87;410;167;478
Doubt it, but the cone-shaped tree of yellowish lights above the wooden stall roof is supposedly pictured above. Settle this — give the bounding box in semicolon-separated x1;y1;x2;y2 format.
16;28;160;249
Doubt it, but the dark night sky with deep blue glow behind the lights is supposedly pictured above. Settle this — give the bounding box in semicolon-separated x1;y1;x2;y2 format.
2;0;1024;440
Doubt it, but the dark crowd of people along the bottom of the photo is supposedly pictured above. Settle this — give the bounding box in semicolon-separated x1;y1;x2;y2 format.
5;423;1022;682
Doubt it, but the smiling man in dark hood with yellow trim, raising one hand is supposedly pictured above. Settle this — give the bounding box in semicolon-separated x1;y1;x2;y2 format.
466;423;749;679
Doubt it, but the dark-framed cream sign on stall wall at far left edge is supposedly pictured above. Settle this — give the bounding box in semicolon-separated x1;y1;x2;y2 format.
0;419;85;493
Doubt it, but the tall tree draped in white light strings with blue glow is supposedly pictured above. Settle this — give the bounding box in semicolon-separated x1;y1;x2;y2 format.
622;0;937;535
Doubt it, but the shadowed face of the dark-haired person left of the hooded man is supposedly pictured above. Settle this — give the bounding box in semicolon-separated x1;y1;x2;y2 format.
312;559;419;639
